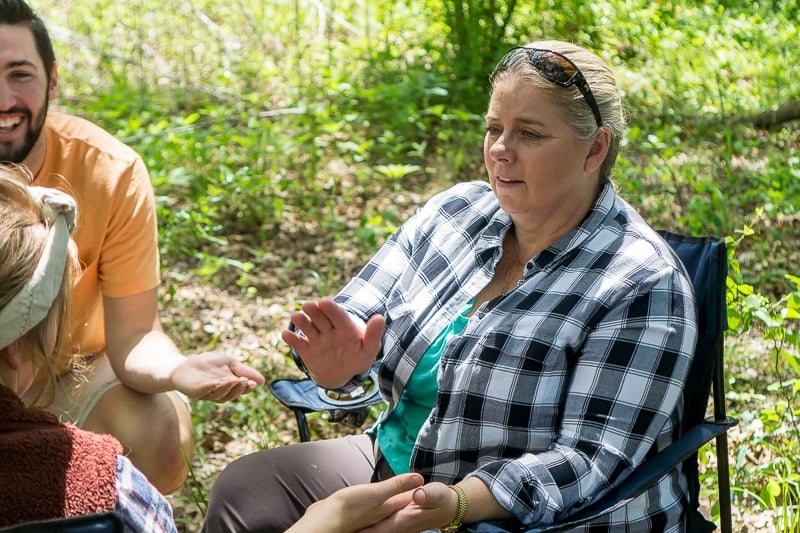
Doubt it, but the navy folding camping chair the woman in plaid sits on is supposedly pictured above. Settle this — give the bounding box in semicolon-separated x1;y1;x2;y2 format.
270;231;738;533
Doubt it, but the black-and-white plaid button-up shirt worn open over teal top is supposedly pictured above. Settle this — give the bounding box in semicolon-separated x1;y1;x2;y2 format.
316;182;697;531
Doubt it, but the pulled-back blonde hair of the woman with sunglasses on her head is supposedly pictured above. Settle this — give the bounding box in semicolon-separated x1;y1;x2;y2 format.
492;41;625;182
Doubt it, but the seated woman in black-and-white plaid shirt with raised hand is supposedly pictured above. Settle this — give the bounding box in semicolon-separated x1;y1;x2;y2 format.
205;41;697;532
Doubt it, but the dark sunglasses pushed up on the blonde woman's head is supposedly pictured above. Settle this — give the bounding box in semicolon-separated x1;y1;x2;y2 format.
489;46;603;128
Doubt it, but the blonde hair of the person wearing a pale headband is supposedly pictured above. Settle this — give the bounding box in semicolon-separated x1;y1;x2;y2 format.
0;164;77;405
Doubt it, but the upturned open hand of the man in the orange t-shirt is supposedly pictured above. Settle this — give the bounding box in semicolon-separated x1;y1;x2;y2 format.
172;352;265;403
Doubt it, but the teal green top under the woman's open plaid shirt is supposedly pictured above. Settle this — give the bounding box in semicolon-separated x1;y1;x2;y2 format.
377;300;473;474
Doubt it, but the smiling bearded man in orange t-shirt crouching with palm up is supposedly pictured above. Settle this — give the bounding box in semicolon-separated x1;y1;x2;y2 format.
0;0;264;492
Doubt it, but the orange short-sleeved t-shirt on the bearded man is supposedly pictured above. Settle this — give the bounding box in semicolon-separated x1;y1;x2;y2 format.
35;111;160;355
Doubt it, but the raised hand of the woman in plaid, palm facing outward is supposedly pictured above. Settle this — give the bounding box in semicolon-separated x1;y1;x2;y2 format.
282;298;386;389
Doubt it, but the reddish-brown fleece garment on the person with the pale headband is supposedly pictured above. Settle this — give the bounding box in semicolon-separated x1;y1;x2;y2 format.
0;385;122;527
